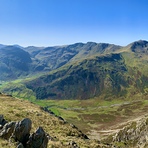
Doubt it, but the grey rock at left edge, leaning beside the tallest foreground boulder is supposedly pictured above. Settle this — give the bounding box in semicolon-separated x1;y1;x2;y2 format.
0;122;16;139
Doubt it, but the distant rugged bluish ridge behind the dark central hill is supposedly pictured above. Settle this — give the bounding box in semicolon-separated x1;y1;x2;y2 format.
25;42;120;70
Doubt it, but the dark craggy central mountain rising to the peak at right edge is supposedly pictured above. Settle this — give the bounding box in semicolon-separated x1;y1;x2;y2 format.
25;41;148;99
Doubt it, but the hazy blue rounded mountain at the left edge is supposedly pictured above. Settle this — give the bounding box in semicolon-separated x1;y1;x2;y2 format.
0;46;32;80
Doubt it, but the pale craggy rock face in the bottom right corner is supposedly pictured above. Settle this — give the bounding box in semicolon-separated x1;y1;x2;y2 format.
113;118;148;148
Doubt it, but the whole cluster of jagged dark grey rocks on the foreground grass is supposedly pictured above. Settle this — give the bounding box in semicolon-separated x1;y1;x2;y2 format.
0;115;49;148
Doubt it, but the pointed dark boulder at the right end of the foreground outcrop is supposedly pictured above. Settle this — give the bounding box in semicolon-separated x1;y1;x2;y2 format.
26;127;48;148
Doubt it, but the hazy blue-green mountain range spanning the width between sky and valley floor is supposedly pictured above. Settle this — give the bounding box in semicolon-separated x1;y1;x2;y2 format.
0;40;148;99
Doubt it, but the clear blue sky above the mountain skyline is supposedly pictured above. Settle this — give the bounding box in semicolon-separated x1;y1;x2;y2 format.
0;0;148;46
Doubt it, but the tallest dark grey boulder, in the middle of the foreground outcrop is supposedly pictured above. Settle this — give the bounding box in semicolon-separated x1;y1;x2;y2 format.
13;118;32;146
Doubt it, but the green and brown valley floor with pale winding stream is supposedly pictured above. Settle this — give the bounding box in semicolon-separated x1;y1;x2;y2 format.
33;96;148;140
